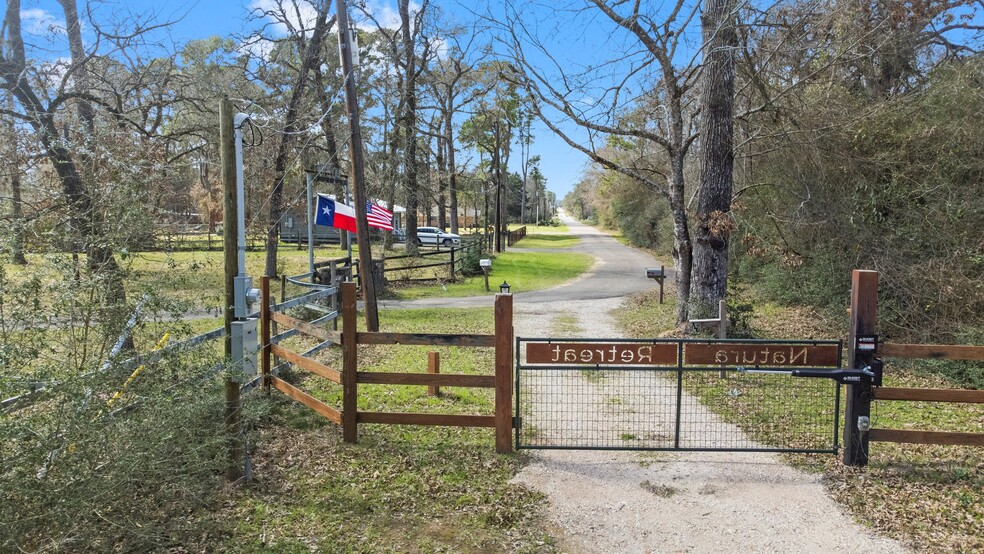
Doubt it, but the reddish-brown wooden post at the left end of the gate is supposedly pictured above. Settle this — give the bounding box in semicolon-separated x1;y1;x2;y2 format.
495;294;515;454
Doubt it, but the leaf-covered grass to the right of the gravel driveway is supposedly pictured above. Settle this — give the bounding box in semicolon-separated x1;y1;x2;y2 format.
616;282;984;552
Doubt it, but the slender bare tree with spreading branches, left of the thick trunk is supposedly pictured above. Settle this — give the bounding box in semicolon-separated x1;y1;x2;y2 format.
504;0;699;321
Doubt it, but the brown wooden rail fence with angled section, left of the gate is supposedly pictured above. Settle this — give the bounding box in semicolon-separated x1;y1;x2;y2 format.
260;277;514;453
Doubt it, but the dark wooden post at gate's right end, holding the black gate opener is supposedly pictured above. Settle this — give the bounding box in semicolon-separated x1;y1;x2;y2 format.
844;269;878;466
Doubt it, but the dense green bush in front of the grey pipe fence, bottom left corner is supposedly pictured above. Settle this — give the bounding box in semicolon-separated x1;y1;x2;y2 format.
0;350;236;552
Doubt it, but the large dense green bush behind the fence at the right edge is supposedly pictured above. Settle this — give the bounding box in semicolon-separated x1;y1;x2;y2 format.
735;62;984;341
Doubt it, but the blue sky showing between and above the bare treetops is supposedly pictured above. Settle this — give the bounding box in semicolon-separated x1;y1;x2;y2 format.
13;0;984;198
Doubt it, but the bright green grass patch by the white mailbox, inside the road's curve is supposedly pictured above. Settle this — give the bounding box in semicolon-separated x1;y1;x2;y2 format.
392;251;594;300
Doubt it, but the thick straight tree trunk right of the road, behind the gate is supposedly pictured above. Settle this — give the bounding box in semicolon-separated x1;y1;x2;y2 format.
690;0;738;318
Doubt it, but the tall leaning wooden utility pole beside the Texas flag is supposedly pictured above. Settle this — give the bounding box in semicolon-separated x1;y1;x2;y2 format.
335;0;379;331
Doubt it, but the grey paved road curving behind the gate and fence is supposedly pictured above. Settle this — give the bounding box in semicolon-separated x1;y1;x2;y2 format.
379;215;672;308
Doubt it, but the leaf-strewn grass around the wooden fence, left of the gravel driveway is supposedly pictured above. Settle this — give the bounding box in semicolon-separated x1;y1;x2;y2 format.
224;308;555;553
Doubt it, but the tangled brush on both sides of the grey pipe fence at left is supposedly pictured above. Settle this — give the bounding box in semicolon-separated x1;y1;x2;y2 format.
0;253;246;552
